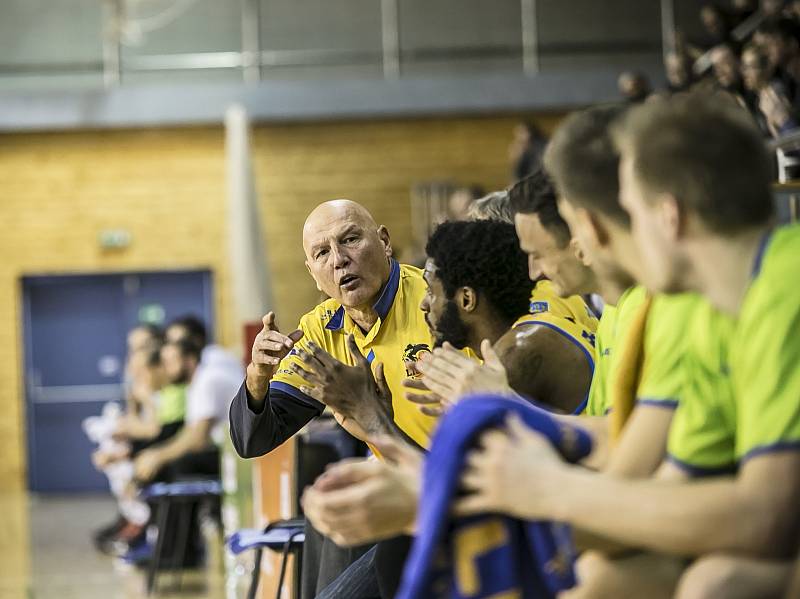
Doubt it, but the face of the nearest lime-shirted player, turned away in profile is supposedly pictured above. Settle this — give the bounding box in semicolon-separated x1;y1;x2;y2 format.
619;151;685;293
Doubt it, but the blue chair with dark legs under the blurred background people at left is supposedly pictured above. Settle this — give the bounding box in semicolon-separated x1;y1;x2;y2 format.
141;480;222;595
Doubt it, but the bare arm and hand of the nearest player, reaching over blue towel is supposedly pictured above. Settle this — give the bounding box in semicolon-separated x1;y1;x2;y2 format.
458;425;800;557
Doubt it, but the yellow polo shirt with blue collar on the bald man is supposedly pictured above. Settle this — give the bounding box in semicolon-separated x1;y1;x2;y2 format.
270;260;437;447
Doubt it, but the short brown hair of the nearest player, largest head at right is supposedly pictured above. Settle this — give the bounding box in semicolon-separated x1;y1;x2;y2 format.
614;93;775;234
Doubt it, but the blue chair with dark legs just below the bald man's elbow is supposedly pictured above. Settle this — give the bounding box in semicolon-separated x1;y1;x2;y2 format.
228;518;306;599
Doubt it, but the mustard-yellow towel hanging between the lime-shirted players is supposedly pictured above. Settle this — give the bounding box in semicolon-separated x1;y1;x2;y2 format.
609;295;652;443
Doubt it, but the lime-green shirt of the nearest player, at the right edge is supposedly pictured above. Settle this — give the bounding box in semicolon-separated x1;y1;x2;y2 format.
730;225;800;460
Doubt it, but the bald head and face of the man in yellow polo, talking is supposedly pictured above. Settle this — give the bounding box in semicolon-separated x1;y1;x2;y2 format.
303;200;392;308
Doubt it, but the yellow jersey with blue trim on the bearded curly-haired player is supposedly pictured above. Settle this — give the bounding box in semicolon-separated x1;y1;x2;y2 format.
513;279;598;400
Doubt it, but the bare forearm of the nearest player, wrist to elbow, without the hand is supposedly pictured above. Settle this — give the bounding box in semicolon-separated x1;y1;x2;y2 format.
551;468;774;555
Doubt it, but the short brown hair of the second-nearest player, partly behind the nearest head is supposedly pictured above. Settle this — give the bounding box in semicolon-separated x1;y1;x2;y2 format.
544;104;630;226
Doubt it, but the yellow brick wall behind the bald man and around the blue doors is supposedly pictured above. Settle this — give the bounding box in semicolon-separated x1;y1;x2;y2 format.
0;115;557;490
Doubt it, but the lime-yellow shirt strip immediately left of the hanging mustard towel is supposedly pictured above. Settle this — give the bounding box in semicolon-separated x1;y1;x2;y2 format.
584;285;646;416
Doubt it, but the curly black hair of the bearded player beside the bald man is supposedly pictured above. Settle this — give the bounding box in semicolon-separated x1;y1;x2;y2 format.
425;220;533;322
